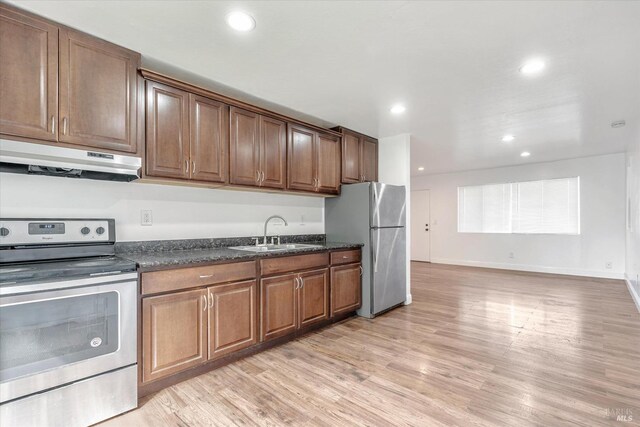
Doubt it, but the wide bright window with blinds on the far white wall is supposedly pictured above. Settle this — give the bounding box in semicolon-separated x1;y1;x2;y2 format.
458;177;580;234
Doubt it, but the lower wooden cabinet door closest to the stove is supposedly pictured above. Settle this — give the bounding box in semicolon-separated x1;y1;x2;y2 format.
143;290;207;382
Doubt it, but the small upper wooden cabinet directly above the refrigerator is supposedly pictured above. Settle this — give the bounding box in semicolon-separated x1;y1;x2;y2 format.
334;127;378;184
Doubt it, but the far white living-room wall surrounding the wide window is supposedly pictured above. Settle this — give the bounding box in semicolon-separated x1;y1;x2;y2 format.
412;153;625;278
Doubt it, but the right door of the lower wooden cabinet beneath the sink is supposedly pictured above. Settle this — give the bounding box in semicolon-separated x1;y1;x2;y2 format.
298;268;329;327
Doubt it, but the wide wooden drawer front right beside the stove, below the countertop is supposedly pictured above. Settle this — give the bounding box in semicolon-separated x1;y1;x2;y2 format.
142;261;256;295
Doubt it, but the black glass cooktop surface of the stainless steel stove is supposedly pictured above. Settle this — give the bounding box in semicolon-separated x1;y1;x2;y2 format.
0;256;136;286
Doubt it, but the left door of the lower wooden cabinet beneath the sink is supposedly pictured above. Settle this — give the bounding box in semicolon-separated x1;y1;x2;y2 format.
260;274;298;341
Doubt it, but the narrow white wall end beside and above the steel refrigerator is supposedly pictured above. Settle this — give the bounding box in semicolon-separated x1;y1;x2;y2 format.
378;134;411;304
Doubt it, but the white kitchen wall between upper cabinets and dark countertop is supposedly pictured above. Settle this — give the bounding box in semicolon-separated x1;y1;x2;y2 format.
0;174;324;241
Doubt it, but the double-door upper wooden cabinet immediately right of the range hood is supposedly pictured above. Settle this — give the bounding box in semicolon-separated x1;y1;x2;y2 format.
146;80;228;183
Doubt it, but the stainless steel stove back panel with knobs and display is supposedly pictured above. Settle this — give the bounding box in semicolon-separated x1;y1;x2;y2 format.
0;219;115;246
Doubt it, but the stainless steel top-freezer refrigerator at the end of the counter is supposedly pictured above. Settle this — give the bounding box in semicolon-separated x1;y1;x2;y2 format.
325;182;407;318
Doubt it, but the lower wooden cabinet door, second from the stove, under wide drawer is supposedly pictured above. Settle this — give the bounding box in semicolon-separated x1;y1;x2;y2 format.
209;280;258;360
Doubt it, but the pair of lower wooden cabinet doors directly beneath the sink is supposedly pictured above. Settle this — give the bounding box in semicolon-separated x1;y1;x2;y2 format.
261;268;329;341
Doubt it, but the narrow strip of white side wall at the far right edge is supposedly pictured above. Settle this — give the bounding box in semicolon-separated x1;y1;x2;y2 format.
626;126;640;310
